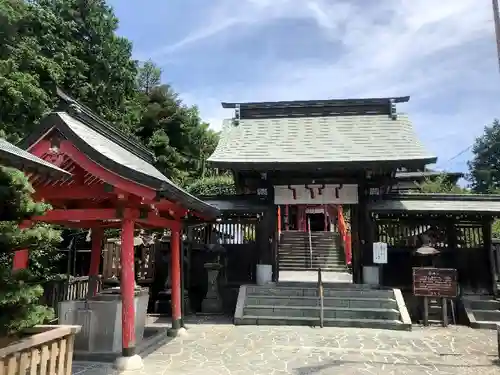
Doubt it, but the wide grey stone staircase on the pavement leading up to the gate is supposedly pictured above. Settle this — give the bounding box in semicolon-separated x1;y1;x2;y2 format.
234;282;411;331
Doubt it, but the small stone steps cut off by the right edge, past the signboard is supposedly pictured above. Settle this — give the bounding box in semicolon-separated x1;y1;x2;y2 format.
462;295;500;329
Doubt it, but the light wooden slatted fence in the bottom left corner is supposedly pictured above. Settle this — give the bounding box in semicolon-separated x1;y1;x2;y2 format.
0;326;80;375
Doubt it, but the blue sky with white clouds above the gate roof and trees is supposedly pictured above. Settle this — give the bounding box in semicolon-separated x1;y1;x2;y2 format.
109;0;500;176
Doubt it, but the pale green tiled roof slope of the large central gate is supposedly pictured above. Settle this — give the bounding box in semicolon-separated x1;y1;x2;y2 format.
208;114;436;167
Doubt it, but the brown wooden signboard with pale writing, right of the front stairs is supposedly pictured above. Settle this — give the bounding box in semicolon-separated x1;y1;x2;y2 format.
413;267;457;298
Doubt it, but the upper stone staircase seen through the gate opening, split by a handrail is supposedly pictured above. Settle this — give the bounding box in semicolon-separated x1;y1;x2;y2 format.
278;231;347;272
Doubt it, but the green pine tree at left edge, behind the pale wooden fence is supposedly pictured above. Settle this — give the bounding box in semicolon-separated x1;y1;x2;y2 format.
0;167;61;337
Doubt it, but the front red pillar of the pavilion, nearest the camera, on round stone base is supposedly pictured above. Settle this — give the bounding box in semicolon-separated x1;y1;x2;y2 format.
120;219;135;357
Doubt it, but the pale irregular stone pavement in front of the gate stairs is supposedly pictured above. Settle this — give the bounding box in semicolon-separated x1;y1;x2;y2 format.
73;318;500;375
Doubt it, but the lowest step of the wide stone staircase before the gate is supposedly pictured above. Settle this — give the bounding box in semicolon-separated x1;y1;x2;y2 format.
234;315;411;331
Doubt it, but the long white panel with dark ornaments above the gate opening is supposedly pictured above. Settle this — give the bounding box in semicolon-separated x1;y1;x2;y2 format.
274;184;358;204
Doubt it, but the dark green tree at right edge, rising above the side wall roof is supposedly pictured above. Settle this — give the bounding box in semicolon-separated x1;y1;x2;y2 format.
468;119;500;193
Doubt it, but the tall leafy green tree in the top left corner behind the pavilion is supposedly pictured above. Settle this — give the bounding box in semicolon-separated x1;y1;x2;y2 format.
0;0;137;141
